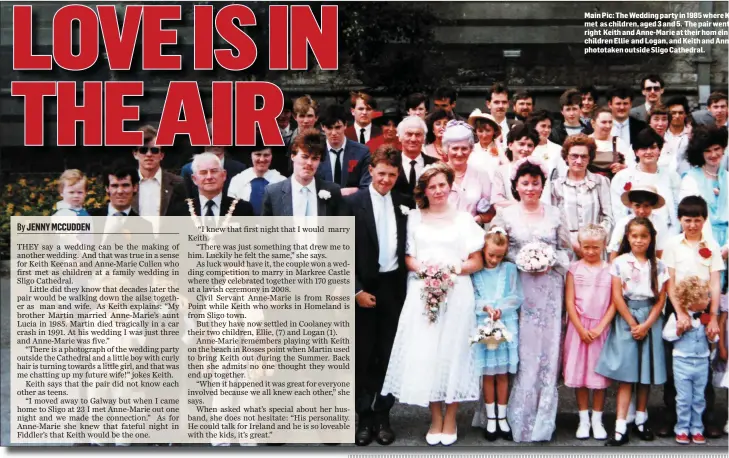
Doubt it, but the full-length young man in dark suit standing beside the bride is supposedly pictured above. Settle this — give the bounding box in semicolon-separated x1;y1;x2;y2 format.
345;145;409;445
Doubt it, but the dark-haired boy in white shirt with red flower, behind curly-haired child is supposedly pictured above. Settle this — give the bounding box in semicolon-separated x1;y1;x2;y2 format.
657;196;726;437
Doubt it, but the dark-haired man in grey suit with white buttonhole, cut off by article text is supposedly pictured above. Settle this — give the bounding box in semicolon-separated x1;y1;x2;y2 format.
261;129;345;217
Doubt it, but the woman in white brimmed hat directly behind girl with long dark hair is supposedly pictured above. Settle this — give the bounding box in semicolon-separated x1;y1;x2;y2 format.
607;184;668;262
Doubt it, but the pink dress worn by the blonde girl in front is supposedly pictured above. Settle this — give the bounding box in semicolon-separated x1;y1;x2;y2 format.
564;261;612;390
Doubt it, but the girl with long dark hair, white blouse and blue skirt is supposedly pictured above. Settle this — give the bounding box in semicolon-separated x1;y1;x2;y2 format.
595;218;668;446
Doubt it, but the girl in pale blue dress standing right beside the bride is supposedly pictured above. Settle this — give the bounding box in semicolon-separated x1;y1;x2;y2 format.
471;227;524;441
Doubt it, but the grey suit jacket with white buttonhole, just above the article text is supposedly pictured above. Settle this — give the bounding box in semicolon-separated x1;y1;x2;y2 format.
261;177;346;216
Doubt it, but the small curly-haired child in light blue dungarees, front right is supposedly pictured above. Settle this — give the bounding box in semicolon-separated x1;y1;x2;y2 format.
663;276;711;444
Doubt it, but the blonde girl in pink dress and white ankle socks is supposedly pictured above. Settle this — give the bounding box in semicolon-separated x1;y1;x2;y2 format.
564;224;615;440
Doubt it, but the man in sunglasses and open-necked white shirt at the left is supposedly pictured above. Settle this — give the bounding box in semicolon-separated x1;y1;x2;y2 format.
132;125;185;222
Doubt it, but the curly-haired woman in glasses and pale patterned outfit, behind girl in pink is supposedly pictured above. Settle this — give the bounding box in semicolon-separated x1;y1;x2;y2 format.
552;134;613;257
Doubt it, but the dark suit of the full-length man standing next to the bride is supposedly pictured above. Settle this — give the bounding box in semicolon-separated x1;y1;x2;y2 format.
345;188;409;421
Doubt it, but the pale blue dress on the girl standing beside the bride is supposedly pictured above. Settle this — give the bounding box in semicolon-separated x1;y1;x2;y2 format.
471;262;524;375
